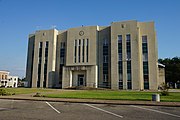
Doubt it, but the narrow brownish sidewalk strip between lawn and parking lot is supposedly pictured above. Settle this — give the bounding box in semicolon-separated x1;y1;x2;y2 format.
0;94;180;107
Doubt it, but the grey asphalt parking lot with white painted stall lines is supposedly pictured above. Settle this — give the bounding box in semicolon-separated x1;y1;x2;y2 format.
0;100;180;120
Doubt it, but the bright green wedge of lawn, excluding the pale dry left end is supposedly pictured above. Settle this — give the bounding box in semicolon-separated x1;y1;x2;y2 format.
45;90;180;102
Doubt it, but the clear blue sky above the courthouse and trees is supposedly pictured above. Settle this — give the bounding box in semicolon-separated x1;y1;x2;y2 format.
0;0;180;78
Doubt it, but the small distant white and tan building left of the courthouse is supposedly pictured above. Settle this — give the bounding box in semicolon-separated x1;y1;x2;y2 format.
0;71;18;87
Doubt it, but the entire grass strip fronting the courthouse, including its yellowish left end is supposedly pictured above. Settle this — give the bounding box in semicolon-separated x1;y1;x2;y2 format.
2;88;180;102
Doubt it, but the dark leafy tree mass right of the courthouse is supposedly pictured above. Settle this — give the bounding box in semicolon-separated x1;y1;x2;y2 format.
158;57;180;84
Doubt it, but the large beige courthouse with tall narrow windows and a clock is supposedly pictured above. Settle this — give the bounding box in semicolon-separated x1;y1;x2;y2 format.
26;20;165;90
